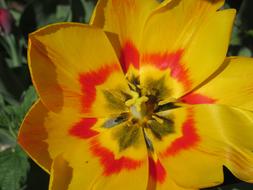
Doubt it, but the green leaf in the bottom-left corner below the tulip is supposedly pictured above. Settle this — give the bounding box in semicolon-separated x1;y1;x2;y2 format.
0;146;30;190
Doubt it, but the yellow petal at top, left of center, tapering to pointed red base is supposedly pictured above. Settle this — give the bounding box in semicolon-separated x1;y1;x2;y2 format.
90;0;159;74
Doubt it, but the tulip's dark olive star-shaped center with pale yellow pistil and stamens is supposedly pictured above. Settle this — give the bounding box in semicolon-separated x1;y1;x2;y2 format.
103;74;179;151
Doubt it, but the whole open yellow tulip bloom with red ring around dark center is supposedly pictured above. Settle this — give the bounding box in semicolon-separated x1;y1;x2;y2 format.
19;0;253;190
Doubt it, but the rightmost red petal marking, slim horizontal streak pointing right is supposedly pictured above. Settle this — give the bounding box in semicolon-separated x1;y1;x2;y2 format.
181;93;216;104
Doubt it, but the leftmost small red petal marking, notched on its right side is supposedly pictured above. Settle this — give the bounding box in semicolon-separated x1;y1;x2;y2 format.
69;118;99;139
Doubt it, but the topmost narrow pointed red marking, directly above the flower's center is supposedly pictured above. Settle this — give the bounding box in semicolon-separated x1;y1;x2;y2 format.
120;41;140;73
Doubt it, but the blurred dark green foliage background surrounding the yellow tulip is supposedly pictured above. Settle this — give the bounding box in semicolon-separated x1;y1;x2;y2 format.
0;0;253;190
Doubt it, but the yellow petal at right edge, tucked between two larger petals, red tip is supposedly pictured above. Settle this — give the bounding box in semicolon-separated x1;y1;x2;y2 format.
183;57;253;111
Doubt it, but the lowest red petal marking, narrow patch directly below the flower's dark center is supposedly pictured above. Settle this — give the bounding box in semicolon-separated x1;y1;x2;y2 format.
148;157;166;183
